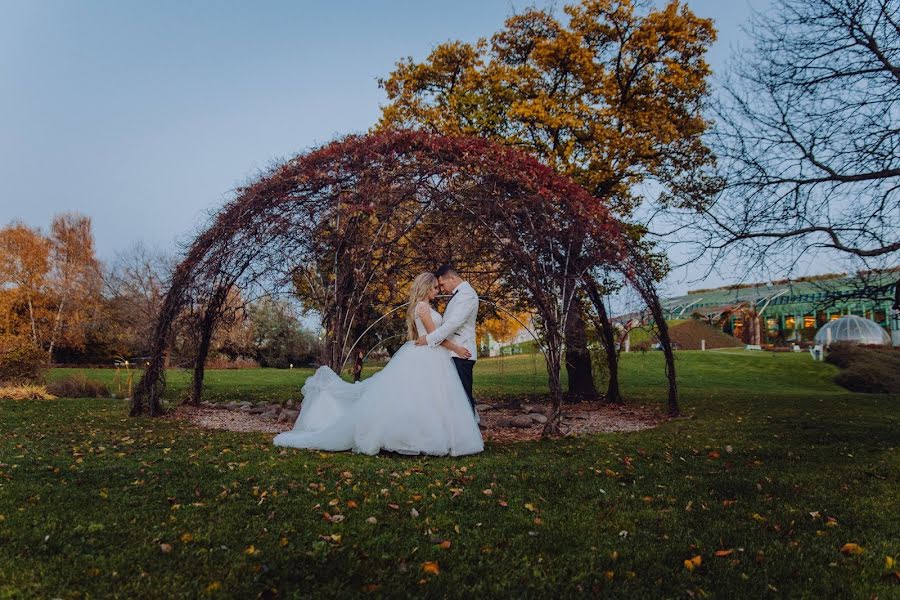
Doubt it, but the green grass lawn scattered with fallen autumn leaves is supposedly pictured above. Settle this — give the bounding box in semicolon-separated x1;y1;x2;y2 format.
7;352;900;599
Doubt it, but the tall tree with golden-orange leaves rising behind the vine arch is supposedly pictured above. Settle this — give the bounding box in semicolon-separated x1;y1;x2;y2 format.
379;0;715;404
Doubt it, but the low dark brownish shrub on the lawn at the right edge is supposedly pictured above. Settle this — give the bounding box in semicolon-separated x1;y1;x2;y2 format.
825;344;900;394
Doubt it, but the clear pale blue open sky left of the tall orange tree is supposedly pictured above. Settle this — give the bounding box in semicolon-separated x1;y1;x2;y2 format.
0;0;768;287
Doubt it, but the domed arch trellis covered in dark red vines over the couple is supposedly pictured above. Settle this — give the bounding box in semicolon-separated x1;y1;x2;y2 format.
132;131;680;426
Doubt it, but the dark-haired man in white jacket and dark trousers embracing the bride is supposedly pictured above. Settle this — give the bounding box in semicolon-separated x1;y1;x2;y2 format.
416;265;478;417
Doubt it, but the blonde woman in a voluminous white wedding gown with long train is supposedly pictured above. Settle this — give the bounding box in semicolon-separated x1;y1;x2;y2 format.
274;273;484;456
